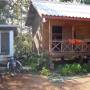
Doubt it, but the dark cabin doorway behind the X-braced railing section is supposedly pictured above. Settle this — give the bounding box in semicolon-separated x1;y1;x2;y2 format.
52;26;62;52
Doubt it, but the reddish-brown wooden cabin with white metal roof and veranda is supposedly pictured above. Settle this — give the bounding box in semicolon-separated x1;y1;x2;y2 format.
26;1;90;60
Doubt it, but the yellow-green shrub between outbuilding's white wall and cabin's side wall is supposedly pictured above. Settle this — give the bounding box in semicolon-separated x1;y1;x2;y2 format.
15;33;32;57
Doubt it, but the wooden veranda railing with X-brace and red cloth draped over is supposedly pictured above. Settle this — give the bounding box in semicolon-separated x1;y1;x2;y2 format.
51;39;89;52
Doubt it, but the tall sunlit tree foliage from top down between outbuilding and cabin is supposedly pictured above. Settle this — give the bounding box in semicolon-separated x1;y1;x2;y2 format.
7;0;32;56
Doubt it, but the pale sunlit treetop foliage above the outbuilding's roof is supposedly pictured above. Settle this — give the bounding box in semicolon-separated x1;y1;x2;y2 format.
0;0;29;32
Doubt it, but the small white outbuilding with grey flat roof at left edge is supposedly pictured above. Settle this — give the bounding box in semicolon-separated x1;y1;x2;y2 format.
0;24;17;62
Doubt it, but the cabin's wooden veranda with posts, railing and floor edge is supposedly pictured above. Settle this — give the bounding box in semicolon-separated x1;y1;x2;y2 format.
48;20;90;58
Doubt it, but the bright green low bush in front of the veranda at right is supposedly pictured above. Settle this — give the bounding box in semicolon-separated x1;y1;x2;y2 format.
59;63;90;76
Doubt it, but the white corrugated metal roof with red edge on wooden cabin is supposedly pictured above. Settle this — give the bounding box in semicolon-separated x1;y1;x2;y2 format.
32;1;90;21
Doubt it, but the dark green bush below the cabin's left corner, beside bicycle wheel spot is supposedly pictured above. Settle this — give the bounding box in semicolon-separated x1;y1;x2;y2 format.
22;54;52;71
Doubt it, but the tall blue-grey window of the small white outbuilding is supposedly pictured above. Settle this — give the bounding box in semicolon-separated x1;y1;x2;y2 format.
0;32;9;55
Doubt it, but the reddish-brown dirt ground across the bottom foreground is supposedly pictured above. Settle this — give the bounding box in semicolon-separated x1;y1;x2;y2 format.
0;74;90;90
